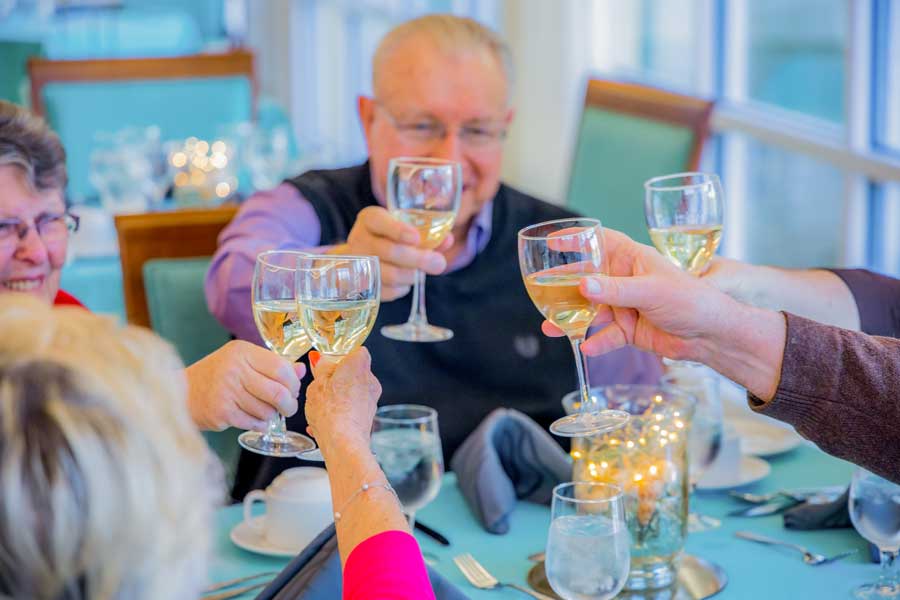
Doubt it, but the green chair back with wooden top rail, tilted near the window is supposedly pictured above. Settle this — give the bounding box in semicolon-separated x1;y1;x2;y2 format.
566;80;712;243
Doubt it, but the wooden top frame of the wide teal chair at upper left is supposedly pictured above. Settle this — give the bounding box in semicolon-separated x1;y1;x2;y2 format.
28;49;257;116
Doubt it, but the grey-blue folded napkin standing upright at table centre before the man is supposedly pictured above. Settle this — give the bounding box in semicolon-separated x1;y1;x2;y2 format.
450;408;572;534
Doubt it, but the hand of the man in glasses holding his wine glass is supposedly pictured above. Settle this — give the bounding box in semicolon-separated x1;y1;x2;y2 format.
333;206;453;301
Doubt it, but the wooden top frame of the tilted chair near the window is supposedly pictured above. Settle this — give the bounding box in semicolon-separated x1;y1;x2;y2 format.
576;79;714;171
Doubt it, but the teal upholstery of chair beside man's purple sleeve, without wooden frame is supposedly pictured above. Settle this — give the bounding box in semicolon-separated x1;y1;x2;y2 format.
143;257;240;489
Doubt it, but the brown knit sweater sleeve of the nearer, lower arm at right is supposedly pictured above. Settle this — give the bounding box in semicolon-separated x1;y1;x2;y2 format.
749;313;900;482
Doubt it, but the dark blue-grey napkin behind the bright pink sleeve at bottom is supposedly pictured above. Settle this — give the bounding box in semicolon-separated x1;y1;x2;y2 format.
256;524;468;600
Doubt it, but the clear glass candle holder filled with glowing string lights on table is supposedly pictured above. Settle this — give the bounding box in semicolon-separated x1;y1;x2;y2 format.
563;385;695;591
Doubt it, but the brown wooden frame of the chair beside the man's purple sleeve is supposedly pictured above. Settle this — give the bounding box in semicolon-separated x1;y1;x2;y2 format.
115;205;237;327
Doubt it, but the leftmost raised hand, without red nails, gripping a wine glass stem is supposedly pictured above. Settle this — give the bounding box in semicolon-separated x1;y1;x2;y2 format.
185;340;306;431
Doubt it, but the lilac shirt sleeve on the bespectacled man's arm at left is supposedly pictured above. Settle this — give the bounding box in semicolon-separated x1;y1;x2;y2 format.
204;183;334;344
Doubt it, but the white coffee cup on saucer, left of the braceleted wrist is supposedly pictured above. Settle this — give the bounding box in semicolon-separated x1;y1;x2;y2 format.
244;467;334;552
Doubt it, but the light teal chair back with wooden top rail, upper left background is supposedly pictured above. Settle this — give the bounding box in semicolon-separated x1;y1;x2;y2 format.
28;51;255;201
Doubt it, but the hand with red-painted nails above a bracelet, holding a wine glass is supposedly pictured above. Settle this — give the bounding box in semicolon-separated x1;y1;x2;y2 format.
305;347;381;446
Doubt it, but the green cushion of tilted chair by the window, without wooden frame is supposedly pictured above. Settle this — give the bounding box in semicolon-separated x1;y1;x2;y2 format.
567;107;693;244
